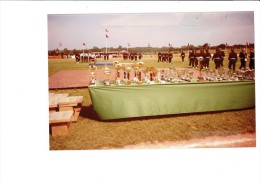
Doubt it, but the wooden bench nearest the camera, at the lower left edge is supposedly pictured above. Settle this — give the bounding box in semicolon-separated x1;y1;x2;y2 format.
49;111;73;136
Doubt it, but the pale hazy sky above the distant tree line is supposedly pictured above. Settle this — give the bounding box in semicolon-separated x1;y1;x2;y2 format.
48;11;254;50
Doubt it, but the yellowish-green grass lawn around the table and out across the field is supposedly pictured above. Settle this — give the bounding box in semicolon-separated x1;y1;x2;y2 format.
49;55;255;150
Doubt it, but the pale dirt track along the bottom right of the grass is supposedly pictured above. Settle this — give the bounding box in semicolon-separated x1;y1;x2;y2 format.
124;133;256;149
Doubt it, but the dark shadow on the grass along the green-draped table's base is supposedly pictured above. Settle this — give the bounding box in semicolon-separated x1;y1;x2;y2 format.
80;105;255;122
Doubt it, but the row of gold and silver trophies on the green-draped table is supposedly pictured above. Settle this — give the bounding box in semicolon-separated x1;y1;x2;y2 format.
89;61;255;86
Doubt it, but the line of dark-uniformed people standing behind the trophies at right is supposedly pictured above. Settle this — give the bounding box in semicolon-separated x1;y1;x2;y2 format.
158;48;255;70
